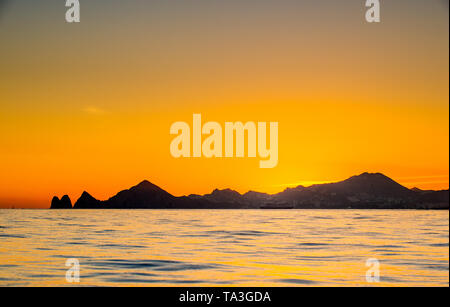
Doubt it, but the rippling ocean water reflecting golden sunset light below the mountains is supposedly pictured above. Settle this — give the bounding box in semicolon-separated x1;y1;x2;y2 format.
0;210;449;286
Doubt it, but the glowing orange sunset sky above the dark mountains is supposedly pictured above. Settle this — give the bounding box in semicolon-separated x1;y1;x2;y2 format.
0;0;449;208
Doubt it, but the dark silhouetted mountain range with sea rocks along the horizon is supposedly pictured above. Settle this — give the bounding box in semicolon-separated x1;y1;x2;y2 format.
51;173;449;209
